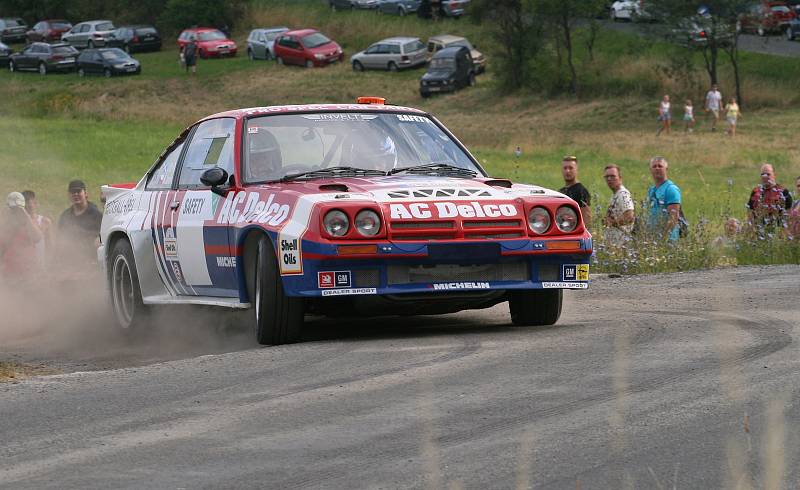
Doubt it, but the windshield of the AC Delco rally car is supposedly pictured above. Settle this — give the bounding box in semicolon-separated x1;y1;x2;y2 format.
242;112;483;183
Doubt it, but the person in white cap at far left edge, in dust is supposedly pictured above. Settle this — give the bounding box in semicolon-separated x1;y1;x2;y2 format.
0;192;42;280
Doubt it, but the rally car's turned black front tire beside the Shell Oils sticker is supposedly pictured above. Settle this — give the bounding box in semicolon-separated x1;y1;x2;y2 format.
251;237;303;345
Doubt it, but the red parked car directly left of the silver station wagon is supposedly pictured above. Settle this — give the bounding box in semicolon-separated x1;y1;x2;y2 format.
275;29;344;68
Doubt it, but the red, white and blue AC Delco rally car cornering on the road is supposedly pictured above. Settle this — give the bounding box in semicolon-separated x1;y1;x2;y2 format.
98;98;592;345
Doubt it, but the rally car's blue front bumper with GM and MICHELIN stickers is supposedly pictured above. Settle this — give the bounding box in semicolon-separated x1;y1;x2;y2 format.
282;238;592;298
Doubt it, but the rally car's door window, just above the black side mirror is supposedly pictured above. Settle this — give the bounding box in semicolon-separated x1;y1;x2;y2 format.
178;118;236;188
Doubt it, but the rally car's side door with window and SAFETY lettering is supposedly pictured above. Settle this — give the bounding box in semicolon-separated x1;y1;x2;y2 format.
169;118;239;297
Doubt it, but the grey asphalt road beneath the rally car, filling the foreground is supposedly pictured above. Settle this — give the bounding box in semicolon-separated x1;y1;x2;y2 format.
0;266;800;489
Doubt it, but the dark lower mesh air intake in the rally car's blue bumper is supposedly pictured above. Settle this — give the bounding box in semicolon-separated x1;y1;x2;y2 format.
387;261;530;285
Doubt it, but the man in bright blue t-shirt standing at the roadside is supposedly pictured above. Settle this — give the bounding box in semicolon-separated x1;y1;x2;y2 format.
647;157;684;242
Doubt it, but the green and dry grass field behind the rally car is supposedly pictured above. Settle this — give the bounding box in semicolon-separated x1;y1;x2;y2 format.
0;1;800;271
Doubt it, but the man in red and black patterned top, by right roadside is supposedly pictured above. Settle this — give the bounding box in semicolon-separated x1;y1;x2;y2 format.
747;163;792;237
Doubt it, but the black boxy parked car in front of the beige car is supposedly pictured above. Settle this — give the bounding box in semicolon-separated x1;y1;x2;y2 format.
419;46;475;97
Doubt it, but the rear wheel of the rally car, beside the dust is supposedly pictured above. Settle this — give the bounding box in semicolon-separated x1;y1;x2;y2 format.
108;239;148;334
